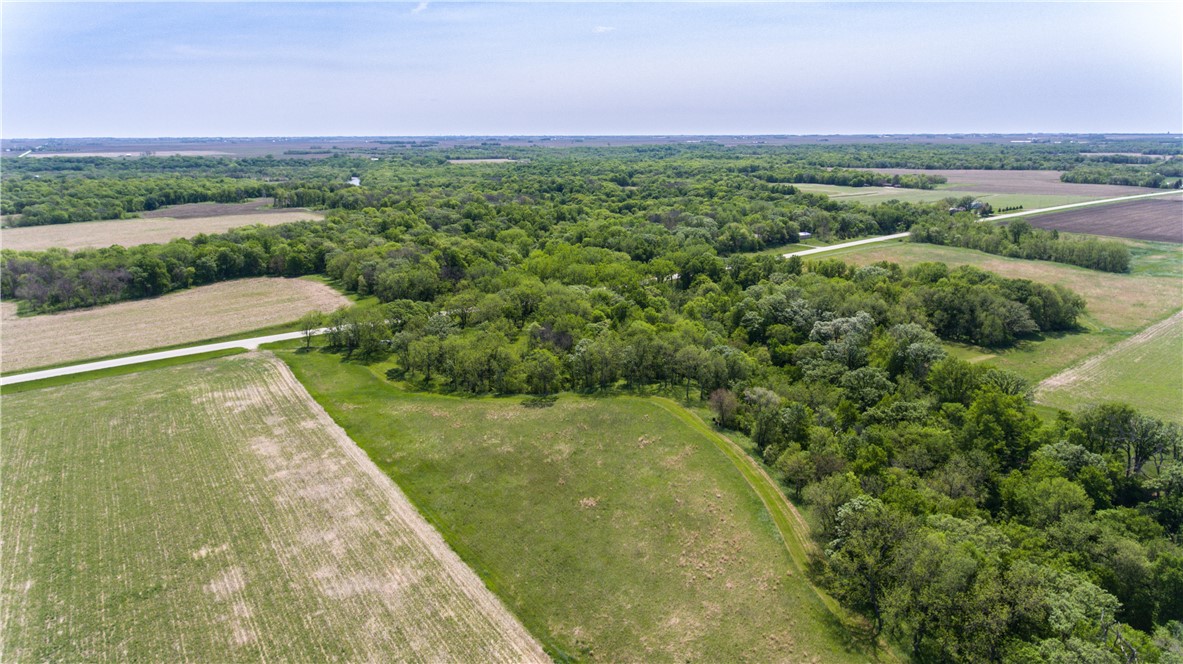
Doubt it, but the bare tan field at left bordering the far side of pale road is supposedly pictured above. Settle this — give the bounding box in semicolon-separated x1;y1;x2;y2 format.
0;278;349;372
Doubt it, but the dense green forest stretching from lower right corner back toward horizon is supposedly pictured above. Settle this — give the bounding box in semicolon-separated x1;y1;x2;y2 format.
0;139;1183;663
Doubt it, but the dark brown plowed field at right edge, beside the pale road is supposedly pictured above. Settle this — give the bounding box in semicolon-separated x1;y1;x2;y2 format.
1027;194;1183;243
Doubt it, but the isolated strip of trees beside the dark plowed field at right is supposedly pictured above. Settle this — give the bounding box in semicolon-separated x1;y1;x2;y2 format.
909;214;1130;272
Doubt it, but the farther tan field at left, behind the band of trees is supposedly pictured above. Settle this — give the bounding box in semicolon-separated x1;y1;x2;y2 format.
0;209;324;251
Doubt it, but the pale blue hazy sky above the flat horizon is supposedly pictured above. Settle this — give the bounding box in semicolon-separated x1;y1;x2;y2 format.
0;0;1183;138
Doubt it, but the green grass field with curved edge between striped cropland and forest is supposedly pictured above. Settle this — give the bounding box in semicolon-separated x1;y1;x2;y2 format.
279;350;868;662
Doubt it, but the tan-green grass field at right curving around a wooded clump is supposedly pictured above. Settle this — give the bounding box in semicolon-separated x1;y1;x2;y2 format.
815;241;1183;382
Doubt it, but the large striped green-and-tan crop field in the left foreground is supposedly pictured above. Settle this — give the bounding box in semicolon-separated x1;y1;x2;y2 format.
0;354;545;662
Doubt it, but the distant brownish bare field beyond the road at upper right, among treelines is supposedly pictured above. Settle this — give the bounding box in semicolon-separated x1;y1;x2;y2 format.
867;168;1158;198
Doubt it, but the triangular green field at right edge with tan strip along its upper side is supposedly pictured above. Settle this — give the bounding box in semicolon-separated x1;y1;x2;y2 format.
1035;311;1183;424
